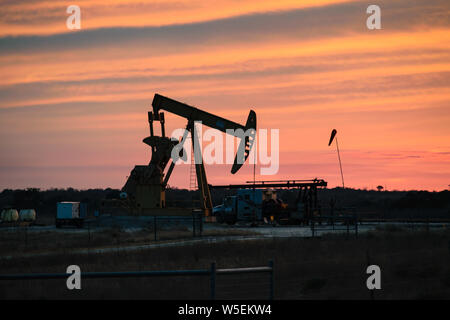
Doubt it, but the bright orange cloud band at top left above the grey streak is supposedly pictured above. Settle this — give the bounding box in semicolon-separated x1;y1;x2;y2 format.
0;0;352;36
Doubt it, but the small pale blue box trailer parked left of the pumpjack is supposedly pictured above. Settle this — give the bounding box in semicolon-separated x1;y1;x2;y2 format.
55;201;87;228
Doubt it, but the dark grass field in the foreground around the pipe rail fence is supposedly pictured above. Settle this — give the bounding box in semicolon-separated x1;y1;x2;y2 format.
0;228;450;299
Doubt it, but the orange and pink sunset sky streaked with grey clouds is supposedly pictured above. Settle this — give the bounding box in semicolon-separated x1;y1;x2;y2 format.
0;0;450;191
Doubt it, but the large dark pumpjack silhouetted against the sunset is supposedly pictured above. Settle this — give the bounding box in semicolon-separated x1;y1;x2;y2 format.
103;94;256;217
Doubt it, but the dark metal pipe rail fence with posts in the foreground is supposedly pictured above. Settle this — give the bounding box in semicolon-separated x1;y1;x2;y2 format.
0;261;274;300
